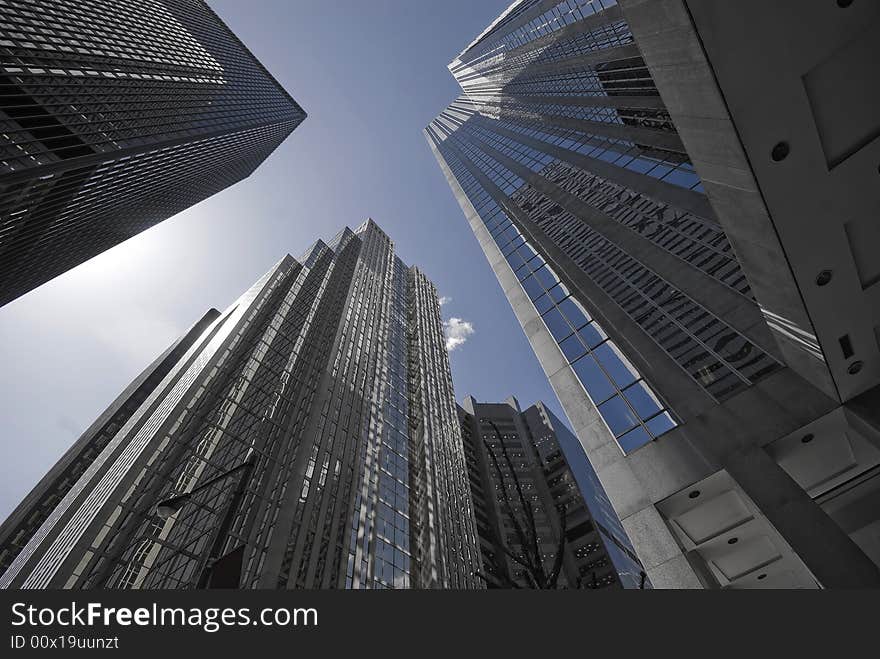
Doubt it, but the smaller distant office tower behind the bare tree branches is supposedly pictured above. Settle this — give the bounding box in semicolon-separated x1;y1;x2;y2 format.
458;396;650;589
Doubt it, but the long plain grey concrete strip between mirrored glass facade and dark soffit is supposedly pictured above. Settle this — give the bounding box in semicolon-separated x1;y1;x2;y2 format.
620;0;837;396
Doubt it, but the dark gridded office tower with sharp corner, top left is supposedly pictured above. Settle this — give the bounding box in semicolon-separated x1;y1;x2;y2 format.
0;0;306;306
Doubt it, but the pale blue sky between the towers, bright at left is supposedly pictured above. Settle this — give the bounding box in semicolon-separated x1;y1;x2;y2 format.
0;0;561;518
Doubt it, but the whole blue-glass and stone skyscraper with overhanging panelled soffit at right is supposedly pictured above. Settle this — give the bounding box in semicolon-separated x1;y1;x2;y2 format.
425;0;880;588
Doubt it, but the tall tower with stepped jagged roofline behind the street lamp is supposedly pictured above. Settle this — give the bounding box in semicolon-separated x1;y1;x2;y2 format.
0;221;481;589
